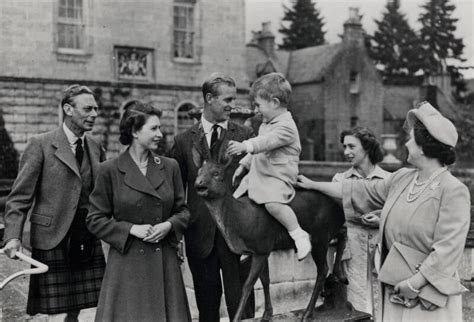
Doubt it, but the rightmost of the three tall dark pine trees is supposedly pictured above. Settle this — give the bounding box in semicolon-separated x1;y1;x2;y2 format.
418;0;465;99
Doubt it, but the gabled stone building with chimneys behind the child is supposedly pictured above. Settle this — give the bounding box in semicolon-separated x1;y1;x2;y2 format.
247;9;383;161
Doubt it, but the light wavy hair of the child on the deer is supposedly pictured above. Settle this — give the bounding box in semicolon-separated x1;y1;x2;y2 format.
250;73;291;107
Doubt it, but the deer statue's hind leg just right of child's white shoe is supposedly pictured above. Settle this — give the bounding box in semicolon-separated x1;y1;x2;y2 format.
302;240;329;321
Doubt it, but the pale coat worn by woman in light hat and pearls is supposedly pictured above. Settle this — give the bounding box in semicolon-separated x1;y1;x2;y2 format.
343;168;470;321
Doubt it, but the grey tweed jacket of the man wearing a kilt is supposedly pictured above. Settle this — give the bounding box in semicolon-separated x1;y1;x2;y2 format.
4;126;105;250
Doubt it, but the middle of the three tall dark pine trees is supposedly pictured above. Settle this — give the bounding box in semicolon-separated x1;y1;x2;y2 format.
367;0;421;84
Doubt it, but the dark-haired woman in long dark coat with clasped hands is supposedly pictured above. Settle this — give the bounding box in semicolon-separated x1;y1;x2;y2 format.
87;103;191;321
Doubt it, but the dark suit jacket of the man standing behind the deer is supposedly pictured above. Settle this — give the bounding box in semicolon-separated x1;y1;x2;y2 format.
171;122;254;258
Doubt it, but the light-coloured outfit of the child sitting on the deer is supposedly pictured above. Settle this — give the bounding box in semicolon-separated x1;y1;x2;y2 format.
234;112;301;204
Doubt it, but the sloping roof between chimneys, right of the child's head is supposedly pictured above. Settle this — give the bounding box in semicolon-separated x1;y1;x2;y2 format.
286;43;342;84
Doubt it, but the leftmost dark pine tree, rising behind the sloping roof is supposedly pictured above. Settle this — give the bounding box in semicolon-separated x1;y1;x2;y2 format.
279;0;326;50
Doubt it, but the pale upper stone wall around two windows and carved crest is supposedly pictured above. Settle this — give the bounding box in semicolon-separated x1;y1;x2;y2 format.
0;0;248;86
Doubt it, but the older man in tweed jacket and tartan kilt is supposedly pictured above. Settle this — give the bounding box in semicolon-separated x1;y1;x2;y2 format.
4;85;105;321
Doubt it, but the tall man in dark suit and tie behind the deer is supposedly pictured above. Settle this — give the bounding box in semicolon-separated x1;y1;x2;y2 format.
171;73;255;322
